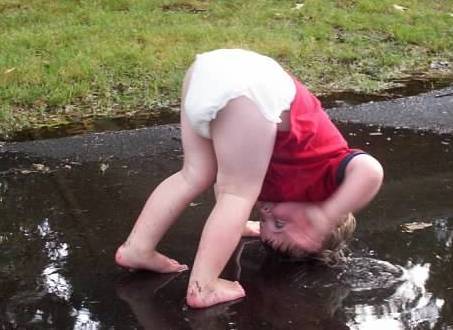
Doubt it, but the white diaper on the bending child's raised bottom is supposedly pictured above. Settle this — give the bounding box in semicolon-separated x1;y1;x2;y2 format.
183;49;296;138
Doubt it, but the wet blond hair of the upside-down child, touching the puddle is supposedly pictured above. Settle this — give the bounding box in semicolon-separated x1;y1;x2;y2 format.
263;213;356;267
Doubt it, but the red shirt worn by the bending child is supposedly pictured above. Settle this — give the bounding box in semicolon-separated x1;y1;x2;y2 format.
258;80;351;202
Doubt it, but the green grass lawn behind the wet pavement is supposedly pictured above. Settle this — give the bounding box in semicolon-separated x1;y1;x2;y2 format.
0;0;453;137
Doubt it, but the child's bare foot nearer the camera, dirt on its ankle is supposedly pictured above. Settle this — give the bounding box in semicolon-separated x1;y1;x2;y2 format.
186;278;245;308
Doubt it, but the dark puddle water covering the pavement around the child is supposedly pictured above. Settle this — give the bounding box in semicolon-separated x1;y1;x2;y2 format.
0;125;453;330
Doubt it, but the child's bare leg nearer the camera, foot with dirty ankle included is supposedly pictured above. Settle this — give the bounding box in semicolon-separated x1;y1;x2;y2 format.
187;97;277;307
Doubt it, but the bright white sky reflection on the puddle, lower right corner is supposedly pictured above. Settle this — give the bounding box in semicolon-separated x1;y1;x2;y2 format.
345;218;453;329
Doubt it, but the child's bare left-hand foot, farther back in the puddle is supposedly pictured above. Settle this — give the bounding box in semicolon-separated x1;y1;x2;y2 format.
115;244;189;273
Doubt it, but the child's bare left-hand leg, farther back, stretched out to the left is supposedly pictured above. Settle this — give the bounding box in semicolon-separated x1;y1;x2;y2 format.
116;66;217;273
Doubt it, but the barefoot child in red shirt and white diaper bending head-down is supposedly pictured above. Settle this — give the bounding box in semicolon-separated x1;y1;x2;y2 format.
116;49;383;308
